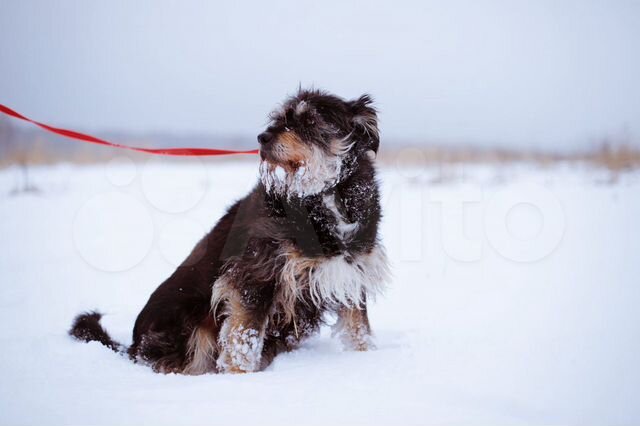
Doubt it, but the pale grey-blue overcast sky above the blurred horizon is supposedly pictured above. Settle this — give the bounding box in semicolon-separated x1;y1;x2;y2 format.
0;0;640;148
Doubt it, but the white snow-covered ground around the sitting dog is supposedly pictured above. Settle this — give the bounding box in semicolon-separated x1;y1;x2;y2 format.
0;160;640;425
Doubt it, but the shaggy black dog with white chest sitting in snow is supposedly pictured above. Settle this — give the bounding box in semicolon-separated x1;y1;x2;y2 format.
69;89;389;375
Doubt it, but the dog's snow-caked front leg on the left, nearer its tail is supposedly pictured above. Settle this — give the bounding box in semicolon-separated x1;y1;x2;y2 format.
217;289;271;373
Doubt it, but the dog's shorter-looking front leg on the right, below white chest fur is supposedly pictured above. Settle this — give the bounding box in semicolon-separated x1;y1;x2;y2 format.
332;303;374;351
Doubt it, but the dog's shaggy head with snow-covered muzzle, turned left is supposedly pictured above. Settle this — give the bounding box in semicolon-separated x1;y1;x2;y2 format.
258;90;380;197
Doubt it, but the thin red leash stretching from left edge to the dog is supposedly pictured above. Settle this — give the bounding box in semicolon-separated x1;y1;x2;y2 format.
0;104;259;157
